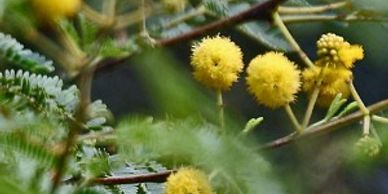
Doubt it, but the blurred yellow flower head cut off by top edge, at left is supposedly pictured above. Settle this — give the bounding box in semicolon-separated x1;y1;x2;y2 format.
31;0;82;23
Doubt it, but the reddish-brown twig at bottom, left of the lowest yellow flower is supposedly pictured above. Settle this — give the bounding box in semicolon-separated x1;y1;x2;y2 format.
91;170;175;185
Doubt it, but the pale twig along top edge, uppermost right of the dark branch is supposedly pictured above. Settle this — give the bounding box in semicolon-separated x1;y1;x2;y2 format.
278;1;348;14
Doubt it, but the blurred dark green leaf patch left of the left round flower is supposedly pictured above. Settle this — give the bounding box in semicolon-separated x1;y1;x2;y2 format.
134;49;217;121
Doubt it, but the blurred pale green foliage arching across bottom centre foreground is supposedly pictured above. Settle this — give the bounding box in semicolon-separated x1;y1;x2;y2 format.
118;119;283;194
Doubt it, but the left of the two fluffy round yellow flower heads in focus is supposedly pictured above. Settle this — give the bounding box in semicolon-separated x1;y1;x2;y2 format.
191;36;244;90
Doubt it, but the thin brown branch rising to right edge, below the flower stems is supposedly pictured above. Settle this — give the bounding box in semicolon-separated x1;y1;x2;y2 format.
259;99;388;150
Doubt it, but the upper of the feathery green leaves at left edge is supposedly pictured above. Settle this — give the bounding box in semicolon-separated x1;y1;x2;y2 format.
0;33;54;73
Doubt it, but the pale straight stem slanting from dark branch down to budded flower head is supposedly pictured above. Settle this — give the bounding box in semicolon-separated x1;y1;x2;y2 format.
273;11;314;67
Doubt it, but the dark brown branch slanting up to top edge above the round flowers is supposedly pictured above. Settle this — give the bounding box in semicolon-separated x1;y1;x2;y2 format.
98;0;286;70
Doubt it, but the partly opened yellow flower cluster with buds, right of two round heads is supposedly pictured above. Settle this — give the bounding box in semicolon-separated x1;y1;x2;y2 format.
303;33;364;107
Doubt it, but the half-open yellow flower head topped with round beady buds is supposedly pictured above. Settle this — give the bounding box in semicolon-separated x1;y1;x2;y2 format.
317;33;364;69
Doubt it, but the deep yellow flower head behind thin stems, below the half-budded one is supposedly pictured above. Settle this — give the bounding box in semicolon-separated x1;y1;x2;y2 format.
302;66;352;107
